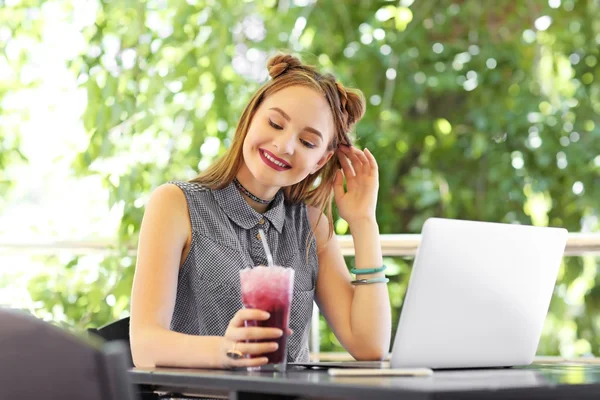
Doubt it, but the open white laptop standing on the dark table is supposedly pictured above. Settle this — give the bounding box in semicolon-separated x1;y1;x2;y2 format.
290;218;567;369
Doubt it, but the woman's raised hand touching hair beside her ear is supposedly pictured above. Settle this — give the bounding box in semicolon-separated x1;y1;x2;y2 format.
333;145;379;226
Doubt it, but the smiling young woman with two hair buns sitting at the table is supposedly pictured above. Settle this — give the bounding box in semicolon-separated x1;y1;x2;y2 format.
131;55;391;368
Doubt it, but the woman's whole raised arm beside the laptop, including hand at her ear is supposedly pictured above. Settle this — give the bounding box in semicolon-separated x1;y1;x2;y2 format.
309;146;392;360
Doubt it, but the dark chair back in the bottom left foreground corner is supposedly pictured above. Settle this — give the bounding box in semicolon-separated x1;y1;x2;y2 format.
0;308;137;400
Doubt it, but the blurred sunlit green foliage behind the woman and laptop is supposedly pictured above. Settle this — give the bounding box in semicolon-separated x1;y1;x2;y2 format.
0;0;600;355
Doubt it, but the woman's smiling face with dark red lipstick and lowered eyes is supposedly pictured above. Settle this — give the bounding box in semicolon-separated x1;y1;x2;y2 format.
243;86;334;187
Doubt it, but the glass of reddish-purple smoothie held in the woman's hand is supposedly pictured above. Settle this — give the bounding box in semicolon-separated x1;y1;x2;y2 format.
240;265;294;372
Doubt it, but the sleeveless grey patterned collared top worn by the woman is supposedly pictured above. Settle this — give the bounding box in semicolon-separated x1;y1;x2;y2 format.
170;182;319;362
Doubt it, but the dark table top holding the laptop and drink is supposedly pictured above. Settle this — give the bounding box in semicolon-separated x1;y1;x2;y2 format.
129;362;600;400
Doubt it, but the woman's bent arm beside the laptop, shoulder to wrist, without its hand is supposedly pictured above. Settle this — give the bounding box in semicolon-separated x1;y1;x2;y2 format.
308;207;391;360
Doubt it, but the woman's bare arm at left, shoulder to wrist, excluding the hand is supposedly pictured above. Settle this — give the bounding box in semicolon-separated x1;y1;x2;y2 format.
130;185;221;367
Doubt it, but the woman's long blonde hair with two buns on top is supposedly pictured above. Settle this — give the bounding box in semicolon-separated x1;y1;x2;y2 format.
191;54;365;251
